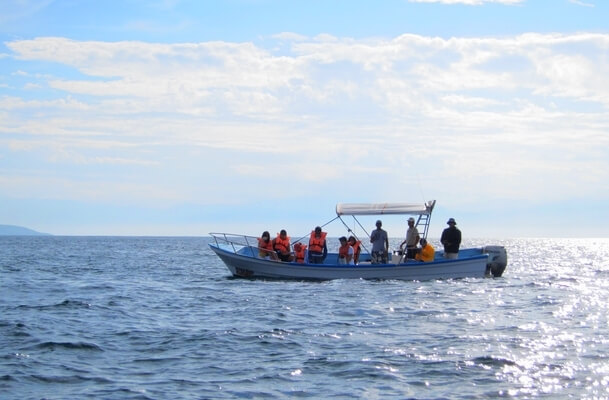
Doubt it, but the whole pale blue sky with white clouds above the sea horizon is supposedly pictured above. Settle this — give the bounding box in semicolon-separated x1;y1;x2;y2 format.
0;0;609;238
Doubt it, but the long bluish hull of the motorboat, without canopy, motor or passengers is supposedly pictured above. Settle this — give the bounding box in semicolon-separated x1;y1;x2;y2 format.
210;244;488;281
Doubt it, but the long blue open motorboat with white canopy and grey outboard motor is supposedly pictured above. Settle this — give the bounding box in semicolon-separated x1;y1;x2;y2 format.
209;200;507;281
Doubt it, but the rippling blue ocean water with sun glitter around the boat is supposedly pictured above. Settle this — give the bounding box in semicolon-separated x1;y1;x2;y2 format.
0;236;609;400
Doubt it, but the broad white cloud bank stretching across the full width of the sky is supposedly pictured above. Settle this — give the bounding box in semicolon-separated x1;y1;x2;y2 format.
0;33;609;208
